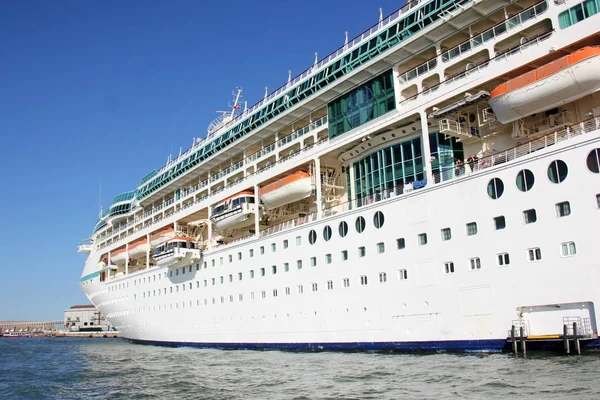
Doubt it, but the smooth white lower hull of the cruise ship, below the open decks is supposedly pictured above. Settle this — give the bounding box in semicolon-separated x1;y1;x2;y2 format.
83;131;600;351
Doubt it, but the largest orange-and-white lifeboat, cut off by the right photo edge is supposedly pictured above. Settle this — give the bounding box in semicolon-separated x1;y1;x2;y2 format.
489;46;600;124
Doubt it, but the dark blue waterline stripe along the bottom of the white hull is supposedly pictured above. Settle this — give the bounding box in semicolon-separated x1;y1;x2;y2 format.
127;339;510;353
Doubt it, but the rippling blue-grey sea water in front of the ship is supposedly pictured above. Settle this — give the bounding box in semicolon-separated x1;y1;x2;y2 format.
0;338;600;400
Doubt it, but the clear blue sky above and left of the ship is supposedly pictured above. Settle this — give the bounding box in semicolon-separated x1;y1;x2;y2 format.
0;0;404;320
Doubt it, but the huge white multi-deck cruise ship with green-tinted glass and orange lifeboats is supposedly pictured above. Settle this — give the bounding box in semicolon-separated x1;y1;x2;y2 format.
79;0;600;352
